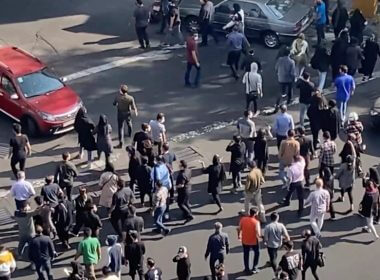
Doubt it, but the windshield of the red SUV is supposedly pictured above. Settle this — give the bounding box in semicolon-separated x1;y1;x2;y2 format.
17;68;64;98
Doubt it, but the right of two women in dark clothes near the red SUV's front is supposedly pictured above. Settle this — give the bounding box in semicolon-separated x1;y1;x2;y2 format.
95;114;112;165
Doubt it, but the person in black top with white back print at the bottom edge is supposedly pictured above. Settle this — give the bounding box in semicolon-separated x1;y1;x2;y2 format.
279;241;302;280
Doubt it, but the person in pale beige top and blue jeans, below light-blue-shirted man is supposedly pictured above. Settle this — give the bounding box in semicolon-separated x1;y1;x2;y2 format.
153;181;170;235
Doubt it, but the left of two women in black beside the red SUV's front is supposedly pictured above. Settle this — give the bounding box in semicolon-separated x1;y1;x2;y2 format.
74;107;97;163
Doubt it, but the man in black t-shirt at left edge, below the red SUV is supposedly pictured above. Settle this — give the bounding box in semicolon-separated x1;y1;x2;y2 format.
8;123;32;178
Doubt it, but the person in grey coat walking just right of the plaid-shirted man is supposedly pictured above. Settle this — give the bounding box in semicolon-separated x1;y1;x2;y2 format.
335;155;355;212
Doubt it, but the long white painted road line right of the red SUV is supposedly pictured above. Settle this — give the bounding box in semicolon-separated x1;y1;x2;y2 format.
62;50;170;82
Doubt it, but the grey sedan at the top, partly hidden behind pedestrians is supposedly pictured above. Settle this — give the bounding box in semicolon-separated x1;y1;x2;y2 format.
179;0;313;48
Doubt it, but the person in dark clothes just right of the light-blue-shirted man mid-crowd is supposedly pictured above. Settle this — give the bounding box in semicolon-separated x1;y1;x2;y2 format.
176;160;194;222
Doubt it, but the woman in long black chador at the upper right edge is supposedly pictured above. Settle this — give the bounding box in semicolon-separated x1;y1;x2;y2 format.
360;34;380;81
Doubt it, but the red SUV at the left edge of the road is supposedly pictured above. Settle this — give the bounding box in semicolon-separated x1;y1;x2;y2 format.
0;47;82;136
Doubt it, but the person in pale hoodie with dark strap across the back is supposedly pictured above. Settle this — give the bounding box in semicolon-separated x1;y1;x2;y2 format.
243;62;263;117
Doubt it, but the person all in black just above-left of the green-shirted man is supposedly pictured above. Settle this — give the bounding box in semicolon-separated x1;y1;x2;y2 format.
53;193;74;249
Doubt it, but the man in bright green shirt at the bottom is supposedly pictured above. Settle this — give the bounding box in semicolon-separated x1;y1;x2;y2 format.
74;228;101;280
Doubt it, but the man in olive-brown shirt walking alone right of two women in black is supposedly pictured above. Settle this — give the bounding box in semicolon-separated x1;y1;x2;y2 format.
113;85;138;149
